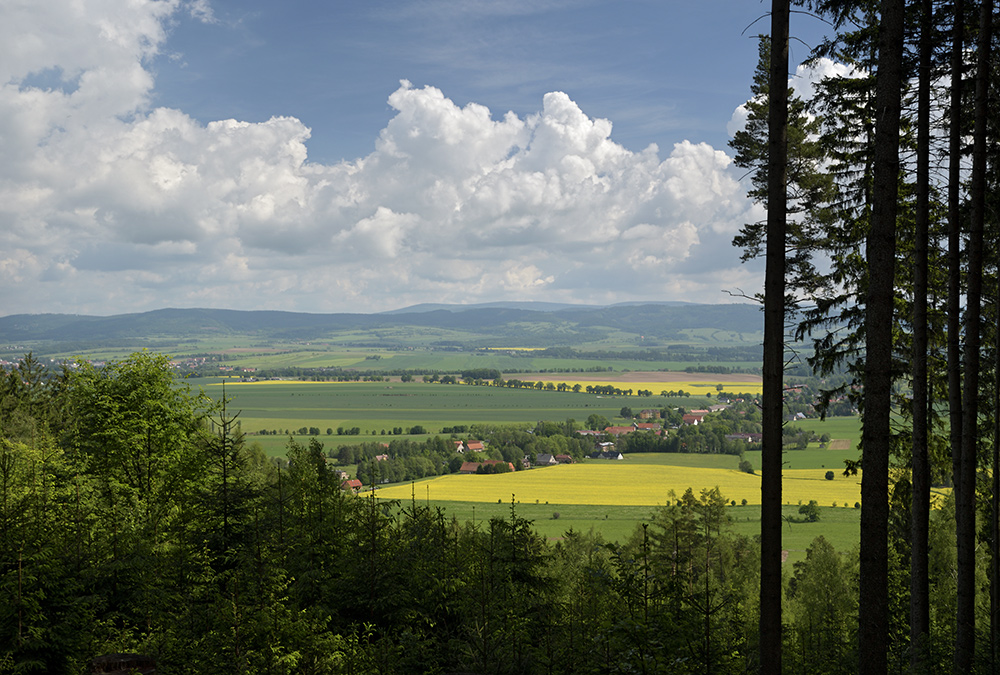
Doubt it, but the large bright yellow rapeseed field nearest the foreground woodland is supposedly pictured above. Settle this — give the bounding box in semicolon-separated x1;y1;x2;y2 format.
377;459;861;507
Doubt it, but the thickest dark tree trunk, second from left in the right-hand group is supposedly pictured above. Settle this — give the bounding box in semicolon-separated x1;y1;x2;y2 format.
858;0;905;674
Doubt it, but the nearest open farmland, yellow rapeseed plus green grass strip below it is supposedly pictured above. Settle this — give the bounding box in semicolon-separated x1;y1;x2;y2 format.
368;454;884;562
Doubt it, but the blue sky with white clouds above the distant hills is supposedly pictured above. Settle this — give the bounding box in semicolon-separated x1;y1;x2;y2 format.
0;0;827;315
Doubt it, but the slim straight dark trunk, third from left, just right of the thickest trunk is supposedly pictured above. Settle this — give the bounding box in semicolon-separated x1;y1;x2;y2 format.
910;0;933;672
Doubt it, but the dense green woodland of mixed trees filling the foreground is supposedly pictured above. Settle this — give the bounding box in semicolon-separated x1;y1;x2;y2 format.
0;353;968;674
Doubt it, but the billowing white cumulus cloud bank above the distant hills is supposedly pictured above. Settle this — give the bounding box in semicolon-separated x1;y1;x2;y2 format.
0;0;760;314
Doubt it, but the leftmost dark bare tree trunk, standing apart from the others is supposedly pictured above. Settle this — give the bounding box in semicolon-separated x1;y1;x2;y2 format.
760;0;789;673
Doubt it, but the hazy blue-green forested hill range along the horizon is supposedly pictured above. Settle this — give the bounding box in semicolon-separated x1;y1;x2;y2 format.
0;304;762;346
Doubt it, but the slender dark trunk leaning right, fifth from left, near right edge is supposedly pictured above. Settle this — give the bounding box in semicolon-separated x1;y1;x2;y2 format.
954;0;993;674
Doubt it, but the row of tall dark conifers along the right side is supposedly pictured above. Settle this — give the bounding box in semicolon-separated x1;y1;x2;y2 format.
733;0;1000;673
